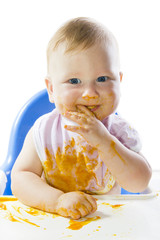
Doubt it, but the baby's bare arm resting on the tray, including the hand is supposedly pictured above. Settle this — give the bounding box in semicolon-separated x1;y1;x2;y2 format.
11;129;97;219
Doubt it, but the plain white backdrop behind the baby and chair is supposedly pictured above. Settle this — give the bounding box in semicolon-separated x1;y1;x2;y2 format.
0;0;160;169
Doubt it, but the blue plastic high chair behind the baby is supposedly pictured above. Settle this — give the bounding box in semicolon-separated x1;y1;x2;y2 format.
1;89;138;195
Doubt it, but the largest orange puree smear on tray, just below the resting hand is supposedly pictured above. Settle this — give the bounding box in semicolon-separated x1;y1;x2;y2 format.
67;216;100;230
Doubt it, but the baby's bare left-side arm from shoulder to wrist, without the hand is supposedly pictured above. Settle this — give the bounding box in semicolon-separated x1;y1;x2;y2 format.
11;129;63;212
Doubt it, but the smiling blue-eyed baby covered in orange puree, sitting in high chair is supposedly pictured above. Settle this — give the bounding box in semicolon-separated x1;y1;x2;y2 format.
11;18;152;219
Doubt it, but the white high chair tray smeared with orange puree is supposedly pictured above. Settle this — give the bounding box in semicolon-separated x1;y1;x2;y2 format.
0;171;160;240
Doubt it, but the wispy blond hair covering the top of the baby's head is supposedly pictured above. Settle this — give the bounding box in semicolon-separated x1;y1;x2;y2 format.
47;18;118;74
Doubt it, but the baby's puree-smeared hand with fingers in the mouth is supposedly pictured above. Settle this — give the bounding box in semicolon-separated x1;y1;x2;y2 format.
64;106;110;148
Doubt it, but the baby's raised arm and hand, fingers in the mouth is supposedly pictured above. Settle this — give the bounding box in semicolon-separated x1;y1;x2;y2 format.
65;106;152;192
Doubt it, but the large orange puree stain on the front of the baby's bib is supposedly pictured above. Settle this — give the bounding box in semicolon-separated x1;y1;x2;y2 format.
43;138;98;192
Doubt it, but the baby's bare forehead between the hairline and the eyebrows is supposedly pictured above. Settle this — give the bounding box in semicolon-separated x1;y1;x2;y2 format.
49;39;119;79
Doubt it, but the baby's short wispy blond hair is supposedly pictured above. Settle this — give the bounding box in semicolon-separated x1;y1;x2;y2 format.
47;17;117;73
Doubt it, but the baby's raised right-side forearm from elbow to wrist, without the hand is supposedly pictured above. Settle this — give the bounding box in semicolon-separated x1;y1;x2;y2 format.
99;136;152;192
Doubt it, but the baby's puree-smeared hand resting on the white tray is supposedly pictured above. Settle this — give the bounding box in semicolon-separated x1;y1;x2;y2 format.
56;191;97;219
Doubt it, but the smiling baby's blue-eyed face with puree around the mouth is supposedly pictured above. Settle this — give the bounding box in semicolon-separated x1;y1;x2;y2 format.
46;41;121;120
